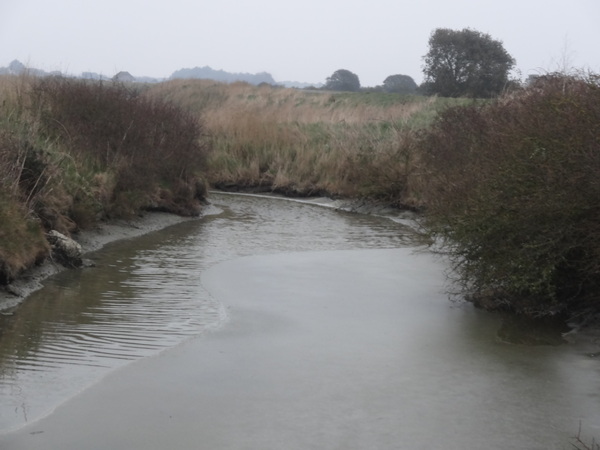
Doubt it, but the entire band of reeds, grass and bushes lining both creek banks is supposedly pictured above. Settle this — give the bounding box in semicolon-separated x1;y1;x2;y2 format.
0;71;600;324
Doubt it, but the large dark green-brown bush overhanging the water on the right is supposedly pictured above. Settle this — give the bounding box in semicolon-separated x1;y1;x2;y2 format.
420;75;600;316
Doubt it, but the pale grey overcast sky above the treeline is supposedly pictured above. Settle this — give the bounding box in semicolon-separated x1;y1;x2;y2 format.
0;0;600;86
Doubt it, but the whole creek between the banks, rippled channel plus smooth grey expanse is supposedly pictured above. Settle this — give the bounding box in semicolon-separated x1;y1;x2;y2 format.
0;194;600;450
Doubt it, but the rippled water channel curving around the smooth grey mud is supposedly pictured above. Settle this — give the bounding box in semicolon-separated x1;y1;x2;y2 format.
0;194;418;430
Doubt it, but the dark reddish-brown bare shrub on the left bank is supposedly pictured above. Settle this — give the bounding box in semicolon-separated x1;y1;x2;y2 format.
32;78;206;215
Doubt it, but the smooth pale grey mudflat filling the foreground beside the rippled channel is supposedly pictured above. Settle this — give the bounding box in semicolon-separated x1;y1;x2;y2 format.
0;248;599;450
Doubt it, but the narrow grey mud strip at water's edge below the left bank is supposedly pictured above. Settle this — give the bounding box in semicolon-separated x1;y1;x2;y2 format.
0;212;199;314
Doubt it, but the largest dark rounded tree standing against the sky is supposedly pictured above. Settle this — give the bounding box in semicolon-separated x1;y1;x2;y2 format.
423;28;515;98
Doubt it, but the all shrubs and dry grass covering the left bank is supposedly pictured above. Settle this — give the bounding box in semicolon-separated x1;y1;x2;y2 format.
0;77;207;283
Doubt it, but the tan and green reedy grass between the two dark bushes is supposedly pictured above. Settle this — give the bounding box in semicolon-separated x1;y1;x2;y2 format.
145;80;468;207
